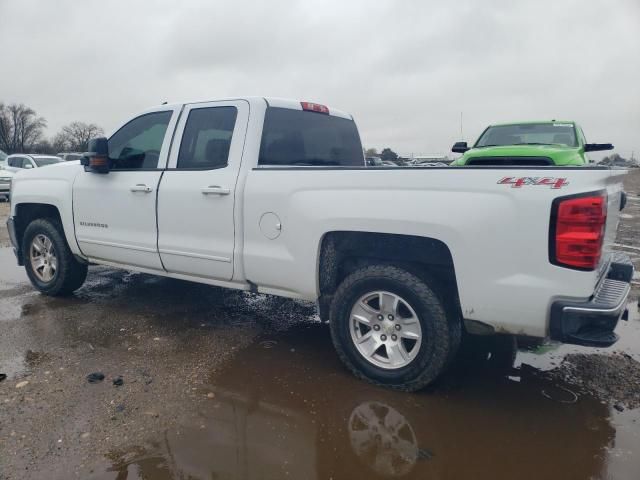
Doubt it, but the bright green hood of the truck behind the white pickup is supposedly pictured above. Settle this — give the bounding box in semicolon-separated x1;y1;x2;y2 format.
452;145;585;165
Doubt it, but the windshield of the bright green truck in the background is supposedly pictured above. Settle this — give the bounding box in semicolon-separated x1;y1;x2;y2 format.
474;123;577;147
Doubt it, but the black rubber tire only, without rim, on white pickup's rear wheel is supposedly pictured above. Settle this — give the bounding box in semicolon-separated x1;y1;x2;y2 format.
330;265;461;391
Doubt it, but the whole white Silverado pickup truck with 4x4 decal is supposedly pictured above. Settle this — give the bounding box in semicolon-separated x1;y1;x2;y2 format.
8;98;633;390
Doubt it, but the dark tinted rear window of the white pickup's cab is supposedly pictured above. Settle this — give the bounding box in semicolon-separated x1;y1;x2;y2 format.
258;107;364;167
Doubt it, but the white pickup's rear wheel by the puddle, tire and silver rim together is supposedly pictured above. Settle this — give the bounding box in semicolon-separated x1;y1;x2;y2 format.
330;265;459;391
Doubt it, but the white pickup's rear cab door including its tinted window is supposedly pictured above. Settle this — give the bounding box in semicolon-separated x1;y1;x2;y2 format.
158;100;249;280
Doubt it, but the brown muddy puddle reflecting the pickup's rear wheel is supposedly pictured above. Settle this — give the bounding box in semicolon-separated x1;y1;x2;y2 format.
99;324;615;480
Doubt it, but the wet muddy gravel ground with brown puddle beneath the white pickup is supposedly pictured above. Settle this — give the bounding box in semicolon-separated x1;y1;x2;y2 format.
0;172;640;480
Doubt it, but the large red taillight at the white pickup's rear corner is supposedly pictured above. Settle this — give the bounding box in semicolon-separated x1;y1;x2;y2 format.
551;195;607;270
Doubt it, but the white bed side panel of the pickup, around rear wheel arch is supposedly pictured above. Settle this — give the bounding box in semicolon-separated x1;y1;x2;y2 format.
243;168;620;336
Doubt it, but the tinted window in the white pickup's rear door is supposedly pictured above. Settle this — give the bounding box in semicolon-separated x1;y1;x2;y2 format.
177;107;238;170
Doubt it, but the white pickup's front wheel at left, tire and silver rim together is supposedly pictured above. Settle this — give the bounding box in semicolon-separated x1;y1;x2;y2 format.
22;218;87;296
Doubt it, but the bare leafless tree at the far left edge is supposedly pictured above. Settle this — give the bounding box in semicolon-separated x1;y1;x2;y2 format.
0;103;47;153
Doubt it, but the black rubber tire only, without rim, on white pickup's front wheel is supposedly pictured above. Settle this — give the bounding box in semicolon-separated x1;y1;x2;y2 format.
22;218;87;297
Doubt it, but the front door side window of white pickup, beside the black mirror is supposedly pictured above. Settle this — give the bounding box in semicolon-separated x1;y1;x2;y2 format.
109;111;173;170
